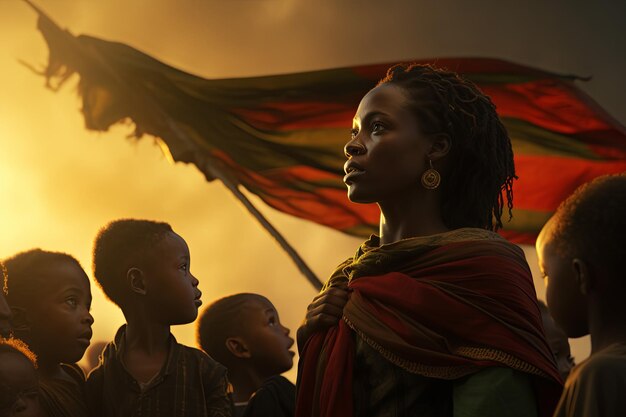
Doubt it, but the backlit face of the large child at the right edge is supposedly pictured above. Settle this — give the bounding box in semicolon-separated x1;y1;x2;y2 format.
537;223;589;337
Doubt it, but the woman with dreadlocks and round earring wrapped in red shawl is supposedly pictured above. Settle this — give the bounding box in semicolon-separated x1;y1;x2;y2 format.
297;65;561;417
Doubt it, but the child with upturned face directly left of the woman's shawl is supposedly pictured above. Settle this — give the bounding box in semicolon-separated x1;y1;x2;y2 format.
198;294;295;416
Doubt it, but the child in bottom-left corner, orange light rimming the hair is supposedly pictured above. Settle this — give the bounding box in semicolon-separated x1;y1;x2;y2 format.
0;338;43;417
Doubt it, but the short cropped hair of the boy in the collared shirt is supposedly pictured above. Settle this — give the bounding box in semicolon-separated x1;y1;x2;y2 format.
93;219;173;306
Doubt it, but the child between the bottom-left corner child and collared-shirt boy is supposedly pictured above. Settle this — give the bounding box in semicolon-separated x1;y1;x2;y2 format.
5;249;93;417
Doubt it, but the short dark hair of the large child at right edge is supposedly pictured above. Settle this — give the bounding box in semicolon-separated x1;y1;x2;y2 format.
550;174;626;278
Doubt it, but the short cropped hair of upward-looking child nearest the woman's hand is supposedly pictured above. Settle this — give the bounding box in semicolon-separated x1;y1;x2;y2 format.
197;293;269;367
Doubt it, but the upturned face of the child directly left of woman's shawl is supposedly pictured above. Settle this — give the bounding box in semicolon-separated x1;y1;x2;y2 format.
243;298;295;378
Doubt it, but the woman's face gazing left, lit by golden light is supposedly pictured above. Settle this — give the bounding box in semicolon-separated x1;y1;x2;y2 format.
344;84;432;203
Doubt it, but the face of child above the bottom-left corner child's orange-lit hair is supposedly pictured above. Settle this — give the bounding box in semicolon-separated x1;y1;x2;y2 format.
28;261;93;363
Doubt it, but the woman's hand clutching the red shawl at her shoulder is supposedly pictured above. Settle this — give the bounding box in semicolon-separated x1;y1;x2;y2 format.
297;284;348;351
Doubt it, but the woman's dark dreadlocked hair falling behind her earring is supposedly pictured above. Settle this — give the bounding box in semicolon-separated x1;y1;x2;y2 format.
378;64;517;231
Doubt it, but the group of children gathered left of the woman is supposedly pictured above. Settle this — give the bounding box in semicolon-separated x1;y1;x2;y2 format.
0;219;295;417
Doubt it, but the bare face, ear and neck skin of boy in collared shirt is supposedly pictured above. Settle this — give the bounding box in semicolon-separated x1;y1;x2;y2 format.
123;233;201;382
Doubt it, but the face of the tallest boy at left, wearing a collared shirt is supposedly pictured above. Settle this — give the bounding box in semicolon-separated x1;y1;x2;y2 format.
143;232;202;325
